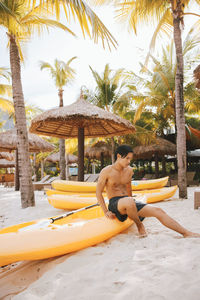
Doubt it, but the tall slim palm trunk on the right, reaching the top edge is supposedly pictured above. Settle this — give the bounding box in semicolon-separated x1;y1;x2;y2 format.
170;0;187;198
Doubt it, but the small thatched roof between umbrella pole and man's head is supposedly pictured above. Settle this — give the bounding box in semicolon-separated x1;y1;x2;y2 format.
85;141;112;159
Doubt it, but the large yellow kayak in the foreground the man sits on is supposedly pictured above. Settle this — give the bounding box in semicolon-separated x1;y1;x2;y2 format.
0;206;133;266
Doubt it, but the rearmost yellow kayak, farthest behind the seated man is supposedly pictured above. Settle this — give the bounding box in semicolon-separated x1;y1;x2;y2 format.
51;176;168;193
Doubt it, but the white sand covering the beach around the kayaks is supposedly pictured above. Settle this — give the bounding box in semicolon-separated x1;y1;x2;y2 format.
0;186;200;300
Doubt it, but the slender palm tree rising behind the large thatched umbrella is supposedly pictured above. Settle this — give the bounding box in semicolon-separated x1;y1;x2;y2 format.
40;57;76;180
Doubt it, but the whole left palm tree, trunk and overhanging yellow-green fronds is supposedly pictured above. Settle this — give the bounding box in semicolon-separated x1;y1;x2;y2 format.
0;0;116;208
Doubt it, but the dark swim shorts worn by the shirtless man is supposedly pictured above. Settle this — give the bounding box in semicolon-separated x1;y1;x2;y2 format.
108;196;146;222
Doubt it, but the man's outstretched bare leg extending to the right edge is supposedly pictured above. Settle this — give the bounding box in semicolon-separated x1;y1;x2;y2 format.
138;205;200;238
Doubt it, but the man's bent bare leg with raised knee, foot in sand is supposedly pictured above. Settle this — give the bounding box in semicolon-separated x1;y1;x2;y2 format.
117;197;147;237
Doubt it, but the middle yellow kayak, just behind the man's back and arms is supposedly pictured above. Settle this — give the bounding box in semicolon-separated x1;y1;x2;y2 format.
48;186;177;210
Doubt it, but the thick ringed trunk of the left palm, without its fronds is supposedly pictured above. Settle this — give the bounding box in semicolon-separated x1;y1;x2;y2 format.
9;35;35;208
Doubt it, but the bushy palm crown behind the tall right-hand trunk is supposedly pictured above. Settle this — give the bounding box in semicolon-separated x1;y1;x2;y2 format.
129;32;200;136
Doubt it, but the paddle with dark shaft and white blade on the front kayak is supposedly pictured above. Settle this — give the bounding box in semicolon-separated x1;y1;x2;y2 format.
19;203;99;231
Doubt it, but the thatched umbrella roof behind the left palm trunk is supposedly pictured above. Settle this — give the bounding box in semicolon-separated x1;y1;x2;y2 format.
0;129;54;152
